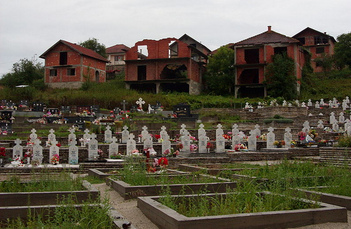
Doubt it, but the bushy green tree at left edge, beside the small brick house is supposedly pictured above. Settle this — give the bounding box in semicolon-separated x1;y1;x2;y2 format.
0;59;44;88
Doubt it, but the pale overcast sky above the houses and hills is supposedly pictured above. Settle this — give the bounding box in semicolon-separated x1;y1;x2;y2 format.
0;0;351;76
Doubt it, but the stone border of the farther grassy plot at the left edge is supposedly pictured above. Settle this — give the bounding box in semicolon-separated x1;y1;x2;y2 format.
0;180;100;208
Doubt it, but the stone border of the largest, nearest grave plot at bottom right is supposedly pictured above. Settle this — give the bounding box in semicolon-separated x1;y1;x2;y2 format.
137;193;347;229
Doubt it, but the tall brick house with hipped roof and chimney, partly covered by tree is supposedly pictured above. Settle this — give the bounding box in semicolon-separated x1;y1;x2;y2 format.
231;26;305;97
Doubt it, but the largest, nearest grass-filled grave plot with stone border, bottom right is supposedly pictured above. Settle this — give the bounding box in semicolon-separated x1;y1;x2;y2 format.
137;192;347;229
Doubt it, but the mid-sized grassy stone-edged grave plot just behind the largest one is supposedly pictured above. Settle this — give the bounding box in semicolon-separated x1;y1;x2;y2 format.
106;162;236;199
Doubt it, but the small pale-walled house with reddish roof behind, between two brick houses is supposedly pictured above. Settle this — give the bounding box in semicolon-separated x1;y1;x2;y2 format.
106;44;130;80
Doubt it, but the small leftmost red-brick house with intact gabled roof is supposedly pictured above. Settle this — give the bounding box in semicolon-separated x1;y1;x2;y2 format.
40;40;108;89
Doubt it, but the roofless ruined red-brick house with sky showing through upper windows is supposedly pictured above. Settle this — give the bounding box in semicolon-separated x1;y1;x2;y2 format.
125;36;209;95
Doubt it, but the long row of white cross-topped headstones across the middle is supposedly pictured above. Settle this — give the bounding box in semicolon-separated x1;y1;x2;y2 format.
13;112;351;164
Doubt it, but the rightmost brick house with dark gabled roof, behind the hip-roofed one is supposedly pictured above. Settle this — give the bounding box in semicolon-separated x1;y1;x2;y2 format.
293;27;336;72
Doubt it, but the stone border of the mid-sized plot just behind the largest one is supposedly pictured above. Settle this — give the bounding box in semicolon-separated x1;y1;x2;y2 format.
106;175;237;200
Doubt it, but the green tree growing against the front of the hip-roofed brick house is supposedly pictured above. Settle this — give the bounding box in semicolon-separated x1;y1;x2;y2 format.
265;54;297;100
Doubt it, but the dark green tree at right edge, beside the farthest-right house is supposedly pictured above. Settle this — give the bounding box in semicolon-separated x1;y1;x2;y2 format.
334;33;351;69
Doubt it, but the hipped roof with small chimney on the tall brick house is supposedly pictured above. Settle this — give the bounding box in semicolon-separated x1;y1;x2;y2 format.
234;29;299;46
